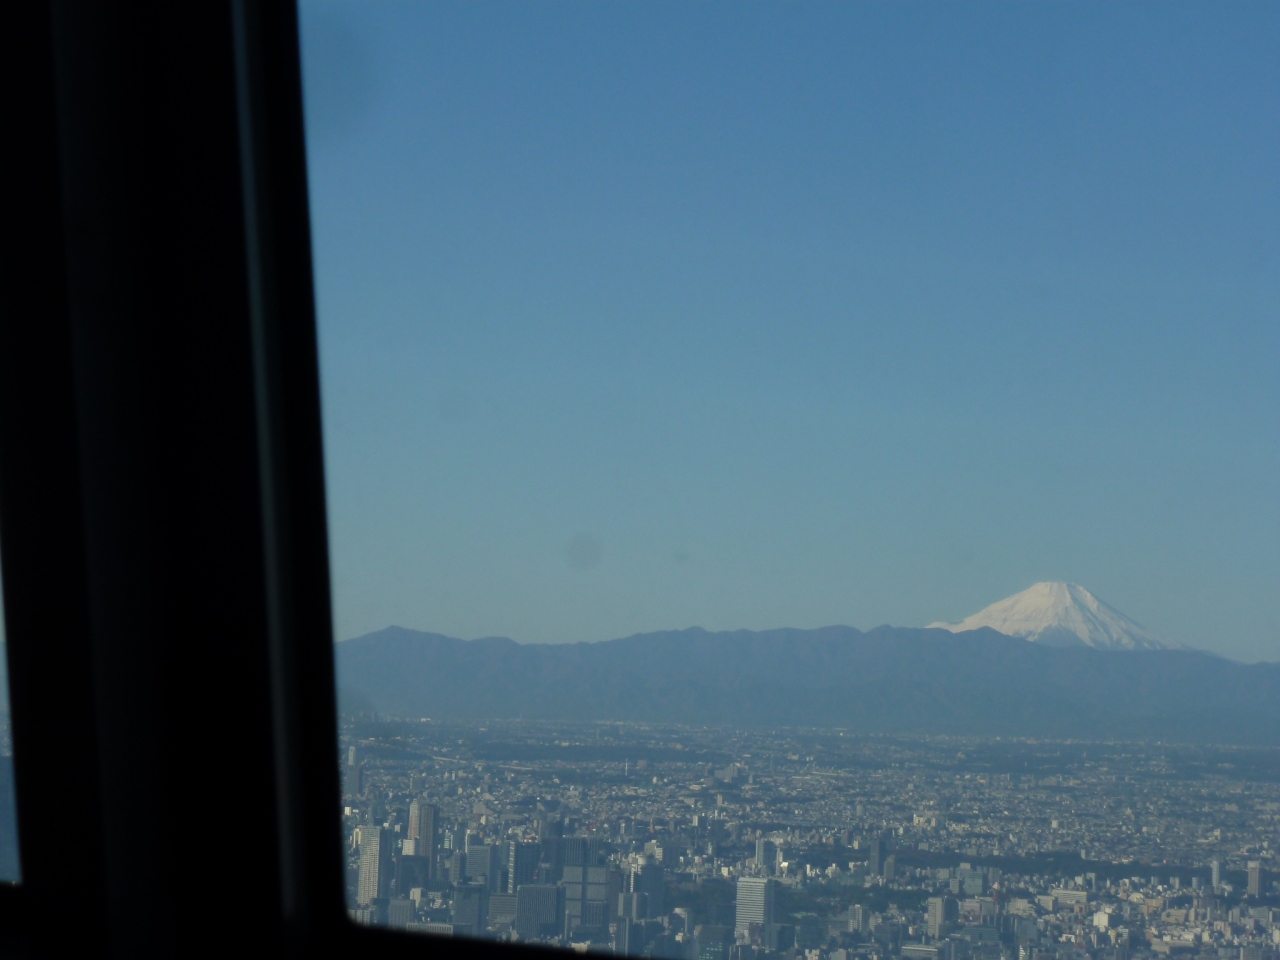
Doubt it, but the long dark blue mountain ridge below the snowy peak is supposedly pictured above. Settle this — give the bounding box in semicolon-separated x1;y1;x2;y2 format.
335;626;1280;745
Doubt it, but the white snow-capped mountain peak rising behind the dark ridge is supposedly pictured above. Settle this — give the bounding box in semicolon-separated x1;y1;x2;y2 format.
929;582;1180;650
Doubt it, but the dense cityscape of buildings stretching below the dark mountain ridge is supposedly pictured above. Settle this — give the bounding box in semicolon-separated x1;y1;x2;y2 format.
342;717;1280;960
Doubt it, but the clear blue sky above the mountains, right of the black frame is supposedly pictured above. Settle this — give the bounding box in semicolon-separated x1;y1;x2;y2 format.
302;0;1280;659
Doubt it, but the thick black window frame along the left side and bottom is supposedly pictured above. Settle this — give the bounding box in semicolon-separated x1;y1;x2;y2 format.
0;0;563;957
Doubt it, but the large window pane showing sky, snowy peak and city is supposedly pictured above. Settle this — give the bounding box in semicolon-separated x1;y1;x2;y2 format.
302;0;1280;960
